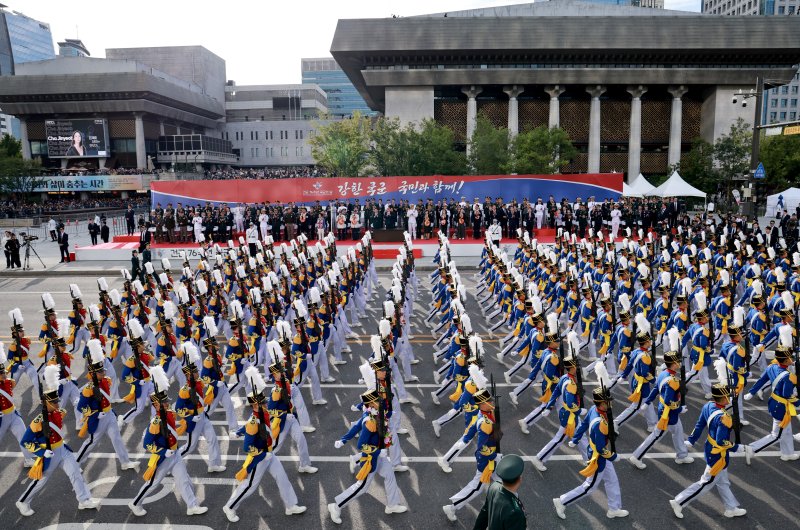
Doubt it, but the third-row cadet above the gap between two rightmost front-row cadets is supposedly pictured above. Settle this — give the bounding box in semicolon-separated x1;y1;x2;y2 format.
611;313;656;432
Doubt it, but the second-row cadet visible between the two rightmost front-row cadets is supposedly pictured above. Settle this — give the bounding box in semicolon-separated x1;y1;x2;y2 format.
629;328;694;469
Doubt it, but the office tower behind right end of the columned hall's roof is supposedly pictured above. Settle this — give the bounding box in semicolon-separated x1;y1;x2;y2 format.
702;0;800;125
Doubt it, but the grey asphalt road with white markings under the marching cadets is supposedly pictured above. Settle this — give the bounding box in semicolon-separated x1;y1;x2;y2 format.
0;270;800;529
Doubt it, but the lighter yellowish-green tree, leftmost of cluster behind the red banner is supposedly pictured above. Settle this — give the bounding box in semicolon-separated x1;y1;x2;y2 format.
310;112;372;177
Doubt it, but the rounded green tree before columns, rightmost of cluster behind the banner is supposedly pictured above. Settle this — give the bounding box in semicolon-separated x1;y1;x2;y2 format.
506;125;578;175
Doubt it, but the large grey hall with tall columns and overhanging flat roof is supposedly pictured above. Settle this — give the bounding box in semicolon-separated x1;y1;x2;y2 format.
331;10;800;176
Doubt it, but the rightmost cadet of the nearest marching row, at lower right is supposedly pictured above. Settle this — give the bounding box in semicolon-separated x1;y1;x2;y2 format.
669;359;747;519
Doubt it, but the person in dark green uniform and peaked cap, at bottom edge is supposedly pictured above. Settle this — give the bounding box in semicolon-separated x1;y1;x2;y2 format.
473;455;528;530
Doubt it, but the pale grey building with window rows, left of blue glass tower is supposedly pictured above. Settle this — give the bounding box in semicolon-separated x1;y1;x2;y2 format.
225;81;329;167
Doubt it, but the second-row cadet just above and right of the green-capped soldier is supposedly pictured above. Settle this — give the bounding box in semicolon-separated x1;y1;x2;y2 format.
533;330;588;471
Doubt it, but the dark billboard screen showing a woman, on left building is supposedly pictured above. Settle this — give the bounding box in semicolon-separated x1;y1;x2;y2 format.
44;119;110;158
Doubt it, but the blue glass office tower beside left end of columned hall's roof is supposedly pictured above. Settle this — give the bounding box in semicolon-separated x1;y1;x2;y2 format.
300;57;376;119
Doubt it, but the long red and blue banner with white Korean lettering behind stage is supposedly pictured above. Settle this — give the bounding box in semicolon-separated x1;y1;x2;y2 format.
150;173;623;207
